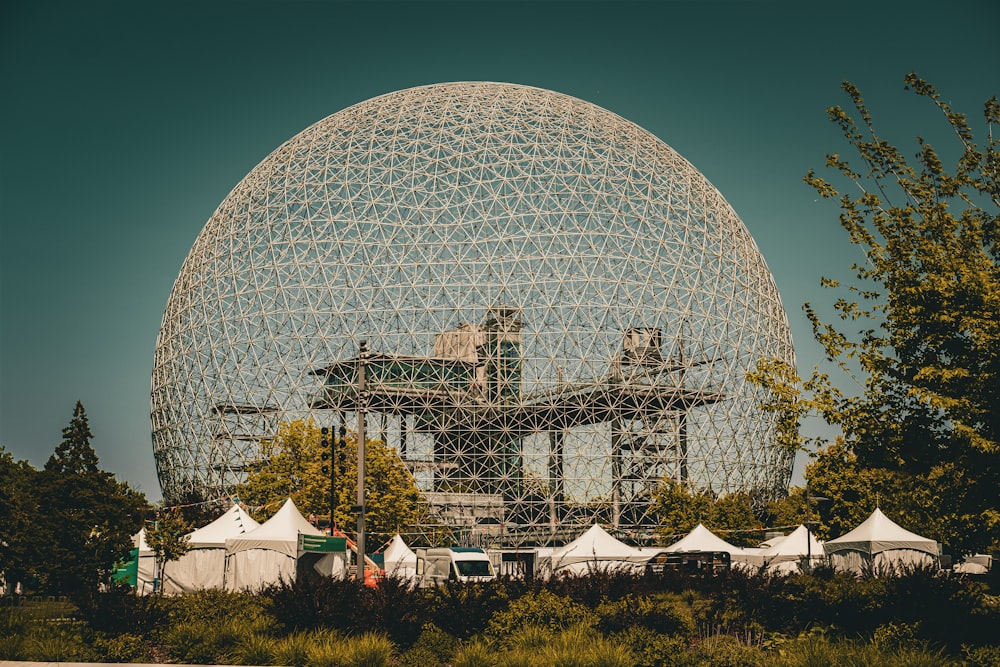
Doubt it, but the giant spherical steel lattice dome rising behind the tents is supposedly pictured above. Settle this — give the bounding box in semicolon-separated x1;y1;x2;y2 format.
151;83;794;527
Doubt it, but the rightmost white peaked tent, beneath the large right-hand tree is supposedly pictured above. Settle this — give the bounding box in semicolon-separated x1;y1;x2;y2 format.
823;508;938;572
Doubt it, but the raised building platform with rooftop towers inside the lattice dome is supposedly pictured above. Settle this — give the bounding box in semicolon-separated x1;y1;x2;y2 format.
311;312;725;436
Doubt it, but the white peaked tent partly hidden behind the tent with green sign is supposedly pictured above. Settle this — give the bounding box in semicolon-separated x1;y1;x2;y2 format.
163;503;260;594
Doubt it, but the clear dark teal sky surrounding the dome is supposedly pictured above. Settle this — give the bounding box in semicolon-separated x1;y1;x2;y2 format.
0;0;1000;500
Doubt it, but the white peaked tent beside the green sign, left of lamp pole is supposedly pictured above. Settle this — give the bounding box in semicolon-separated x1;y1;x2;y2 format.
225;498;323;591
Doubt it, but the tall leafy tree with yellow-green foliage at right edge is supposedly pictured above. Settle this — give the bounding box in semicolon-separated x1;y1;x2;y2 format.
805;73;1000;554
